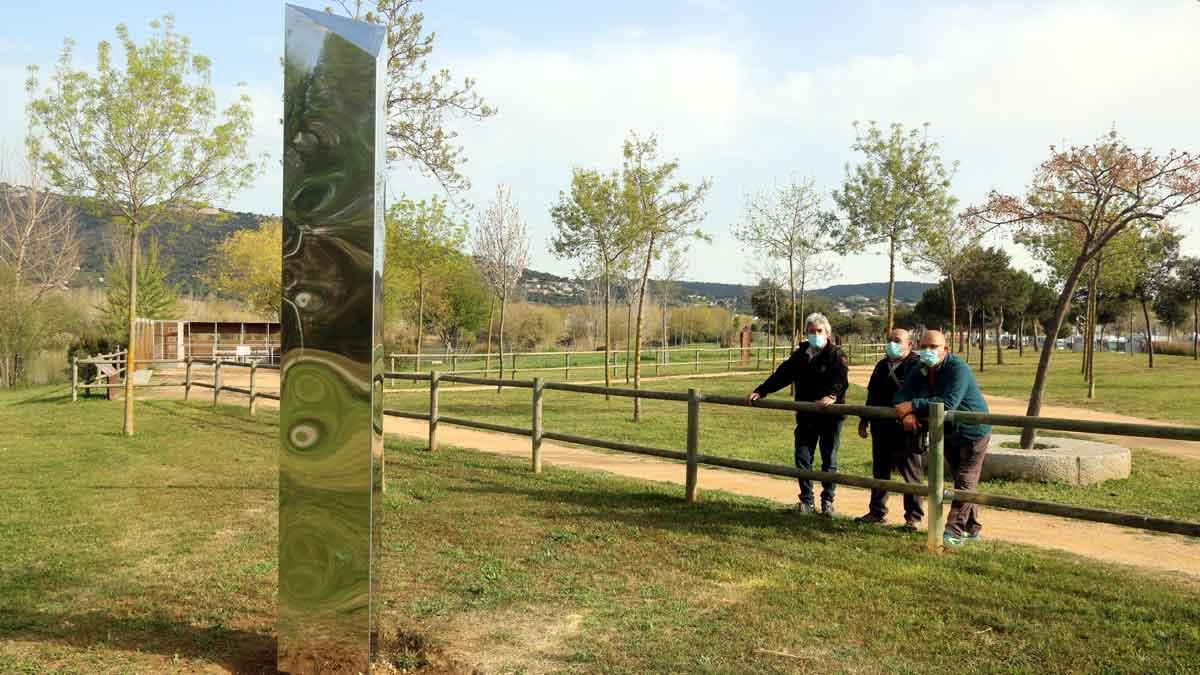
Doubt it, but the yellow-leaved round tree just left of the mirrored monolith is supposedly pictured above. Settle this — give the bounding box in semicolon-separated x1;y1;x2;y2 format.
204;217;283;321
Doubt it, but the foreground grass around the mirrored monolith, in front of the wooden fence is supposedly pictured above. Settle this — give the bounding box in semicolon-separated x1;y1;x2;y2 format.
0;389;1200;674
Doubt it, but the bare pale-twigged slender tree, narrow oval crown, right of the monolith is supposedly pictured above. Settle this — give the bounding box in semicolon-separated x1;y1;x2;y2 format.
474;184;529;390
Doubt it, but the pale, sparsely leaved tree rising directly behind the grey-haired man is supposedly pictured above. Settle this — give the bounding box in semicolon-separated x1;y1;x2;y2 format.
733;178;834;350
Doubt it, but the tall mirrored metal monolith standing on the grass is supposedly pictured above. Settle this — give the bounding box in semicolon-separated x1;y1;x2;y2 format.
278;5;385;673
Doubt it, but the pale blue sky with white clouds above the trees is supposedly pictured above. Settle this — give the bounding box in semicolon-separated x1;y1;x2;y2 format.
0;0;1200;287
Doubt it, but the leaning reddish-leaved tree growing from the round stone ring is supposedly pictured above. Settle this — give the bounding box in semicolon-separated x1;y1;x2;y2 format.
973;131;1200;448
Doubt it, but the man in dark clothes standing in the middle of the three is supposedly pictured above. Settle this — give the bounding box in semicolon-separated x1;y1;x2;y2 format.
854;328;925;532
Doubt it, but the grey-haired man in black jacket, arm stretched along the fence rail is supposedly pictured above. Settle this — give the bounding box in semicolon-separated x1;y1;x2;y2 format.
746;313;848;515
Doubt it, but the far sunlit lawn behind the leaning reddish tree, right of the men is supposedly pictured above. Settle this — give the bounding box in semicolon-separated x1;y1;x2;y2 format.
971;350;1200;425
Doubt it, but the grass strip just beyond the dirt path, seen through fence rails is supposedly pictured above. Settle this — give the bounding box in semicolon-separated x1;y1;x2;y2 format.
389;374;1200;520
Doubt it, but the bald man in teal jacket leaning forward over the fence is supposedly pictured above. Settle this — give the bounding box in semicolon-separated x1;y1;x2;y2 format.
894;330;991;546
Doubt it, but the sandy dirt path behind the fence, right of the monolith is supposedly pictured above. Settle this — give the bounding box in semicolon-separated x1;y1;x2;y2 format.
384;417;1200;580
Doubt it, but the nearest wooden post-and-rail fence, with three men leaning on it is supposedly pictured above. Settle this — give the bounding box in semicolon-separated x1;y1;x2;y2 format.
72;359;1200;551
